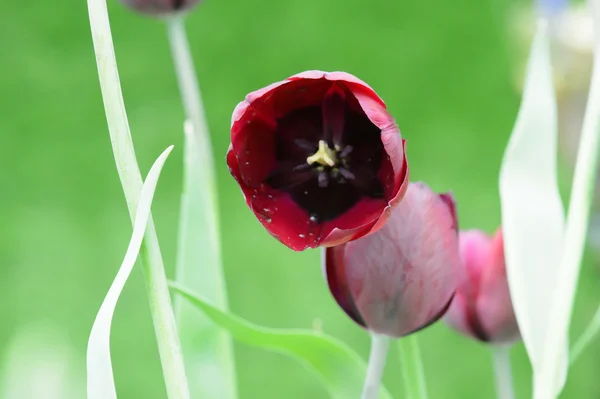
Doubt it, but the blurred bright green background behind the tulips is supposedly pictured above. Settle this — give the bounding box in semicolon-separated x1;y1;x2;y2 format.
0;0;600;399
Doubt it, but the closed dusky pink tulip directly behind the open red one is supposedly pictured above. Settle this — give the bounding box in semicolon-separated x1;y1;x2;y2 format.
324;183;460;337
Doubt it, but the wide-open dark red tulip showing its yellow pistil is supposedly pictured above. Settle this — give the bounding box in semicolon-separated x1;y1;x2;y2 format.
227;71;408;251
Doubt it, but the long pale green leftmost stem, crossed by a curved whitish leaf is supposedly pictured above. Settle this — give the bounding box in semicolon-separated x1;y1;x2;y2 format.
88;0;190;399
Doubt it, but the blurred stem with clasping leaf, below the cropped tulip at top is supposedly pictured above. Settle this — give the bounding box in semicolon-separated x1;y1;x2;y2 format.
166;15;237;399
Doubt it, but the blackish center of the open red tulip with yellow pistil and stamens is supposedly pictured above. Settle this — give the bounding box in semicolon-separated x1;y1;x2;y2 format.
265;83;385;222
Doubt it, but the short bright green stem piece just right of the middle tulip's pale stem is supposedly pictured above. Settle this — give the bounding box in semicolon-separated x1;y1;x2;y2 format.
398;334;427;399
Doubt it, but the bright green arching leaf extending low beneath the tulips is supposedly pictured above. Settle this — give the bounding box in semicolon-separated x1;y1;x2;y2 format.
170;283;391;399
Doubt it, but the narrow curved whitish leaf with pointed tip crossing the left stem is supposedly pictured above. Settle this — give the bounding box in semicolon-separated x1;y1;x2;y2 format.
86;146;173;399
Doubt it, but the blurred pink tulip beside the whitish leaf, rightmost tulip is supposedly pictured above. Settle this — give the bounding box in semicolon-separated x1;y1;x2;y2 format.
444;229;520;344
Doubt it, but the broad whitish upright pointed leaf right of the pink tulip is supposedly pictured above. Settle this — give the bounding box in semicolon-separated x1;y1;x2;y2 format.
500;21;567;391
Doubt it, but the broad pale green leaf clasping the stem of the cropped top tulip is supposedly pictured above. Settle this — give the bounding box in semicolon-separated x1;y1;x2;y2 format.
173;122;237;399
